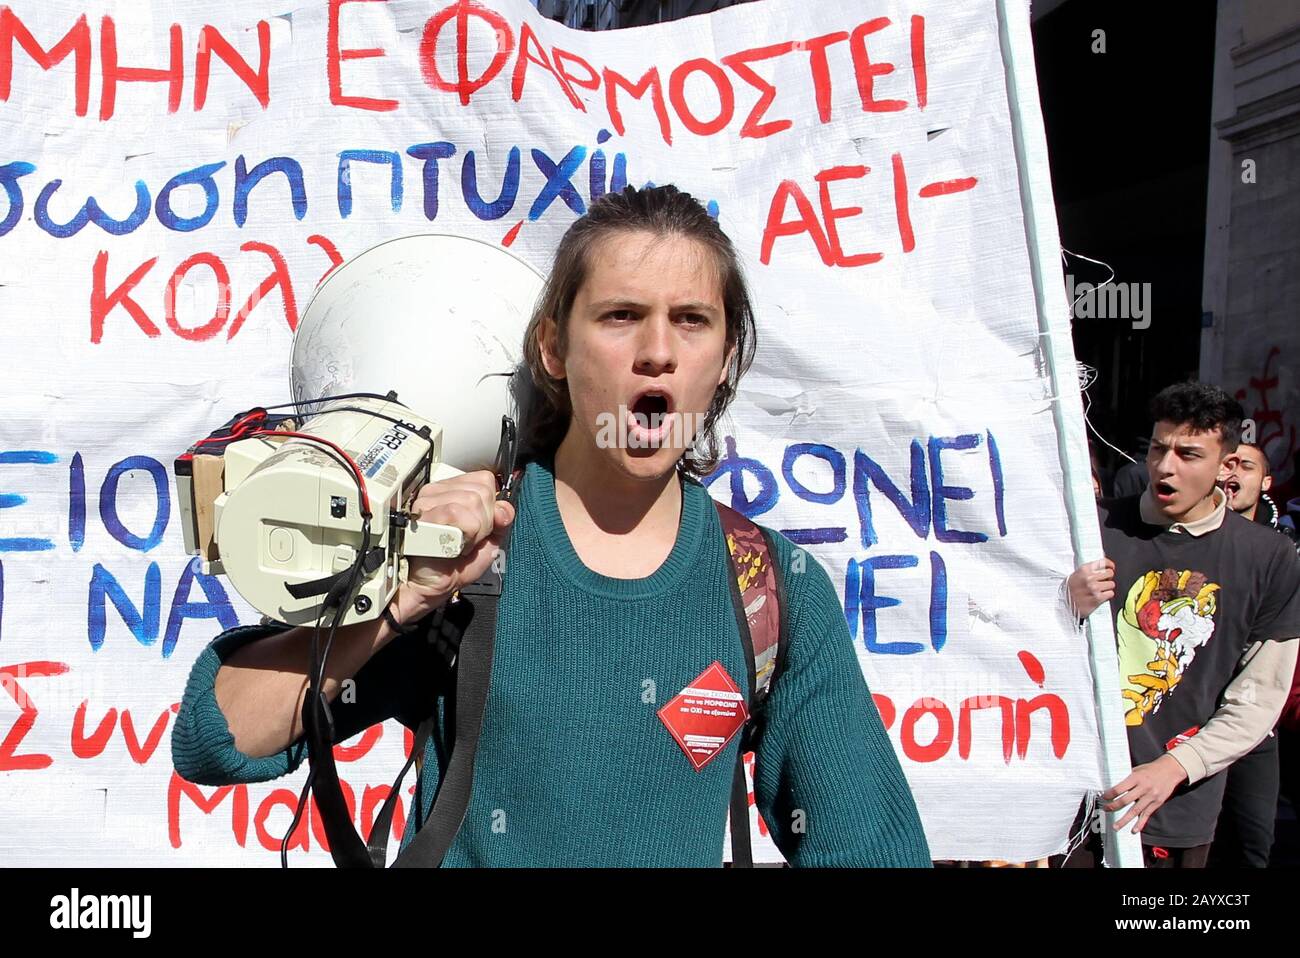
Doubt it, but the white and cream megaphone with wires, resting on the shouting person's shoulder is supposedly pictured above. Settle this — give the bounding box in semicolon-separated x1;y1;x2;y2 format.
176;234;543;625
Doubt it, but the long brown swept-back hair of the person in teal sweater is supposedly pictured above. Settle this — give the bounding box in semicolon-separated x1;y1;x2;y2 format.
515;186;755;478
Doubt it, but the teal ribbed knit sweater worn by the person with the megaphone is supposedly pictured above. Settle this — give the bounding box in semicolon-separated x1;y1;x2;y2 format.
172;461;930;867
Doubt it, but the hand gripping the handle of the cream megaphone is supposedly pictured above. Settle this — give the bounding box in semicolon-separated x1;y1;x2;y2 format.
393;469;515;624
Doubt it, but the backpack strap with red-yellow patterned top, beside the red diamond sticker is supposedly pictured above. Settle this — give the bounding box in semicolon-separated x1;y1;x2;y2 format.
714;500;789;868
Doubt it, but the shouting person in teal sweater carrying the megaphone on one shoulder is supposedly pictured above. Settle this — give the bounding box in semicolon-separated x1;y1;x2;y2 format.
172;187;930;866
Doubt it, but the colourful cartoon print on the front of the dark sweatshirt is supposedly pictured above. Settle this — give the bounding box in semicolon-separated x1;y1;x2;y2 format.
1115;569;1219;725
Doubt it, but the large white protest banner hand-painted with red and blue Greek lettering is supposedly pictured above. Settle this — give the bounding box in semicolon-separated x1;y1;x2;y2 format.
0;0;1118;864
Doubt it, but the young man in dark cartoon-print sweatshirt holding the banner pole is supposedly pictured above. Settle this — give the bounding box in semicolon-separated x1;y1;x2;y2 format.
1067;382;1300;867
